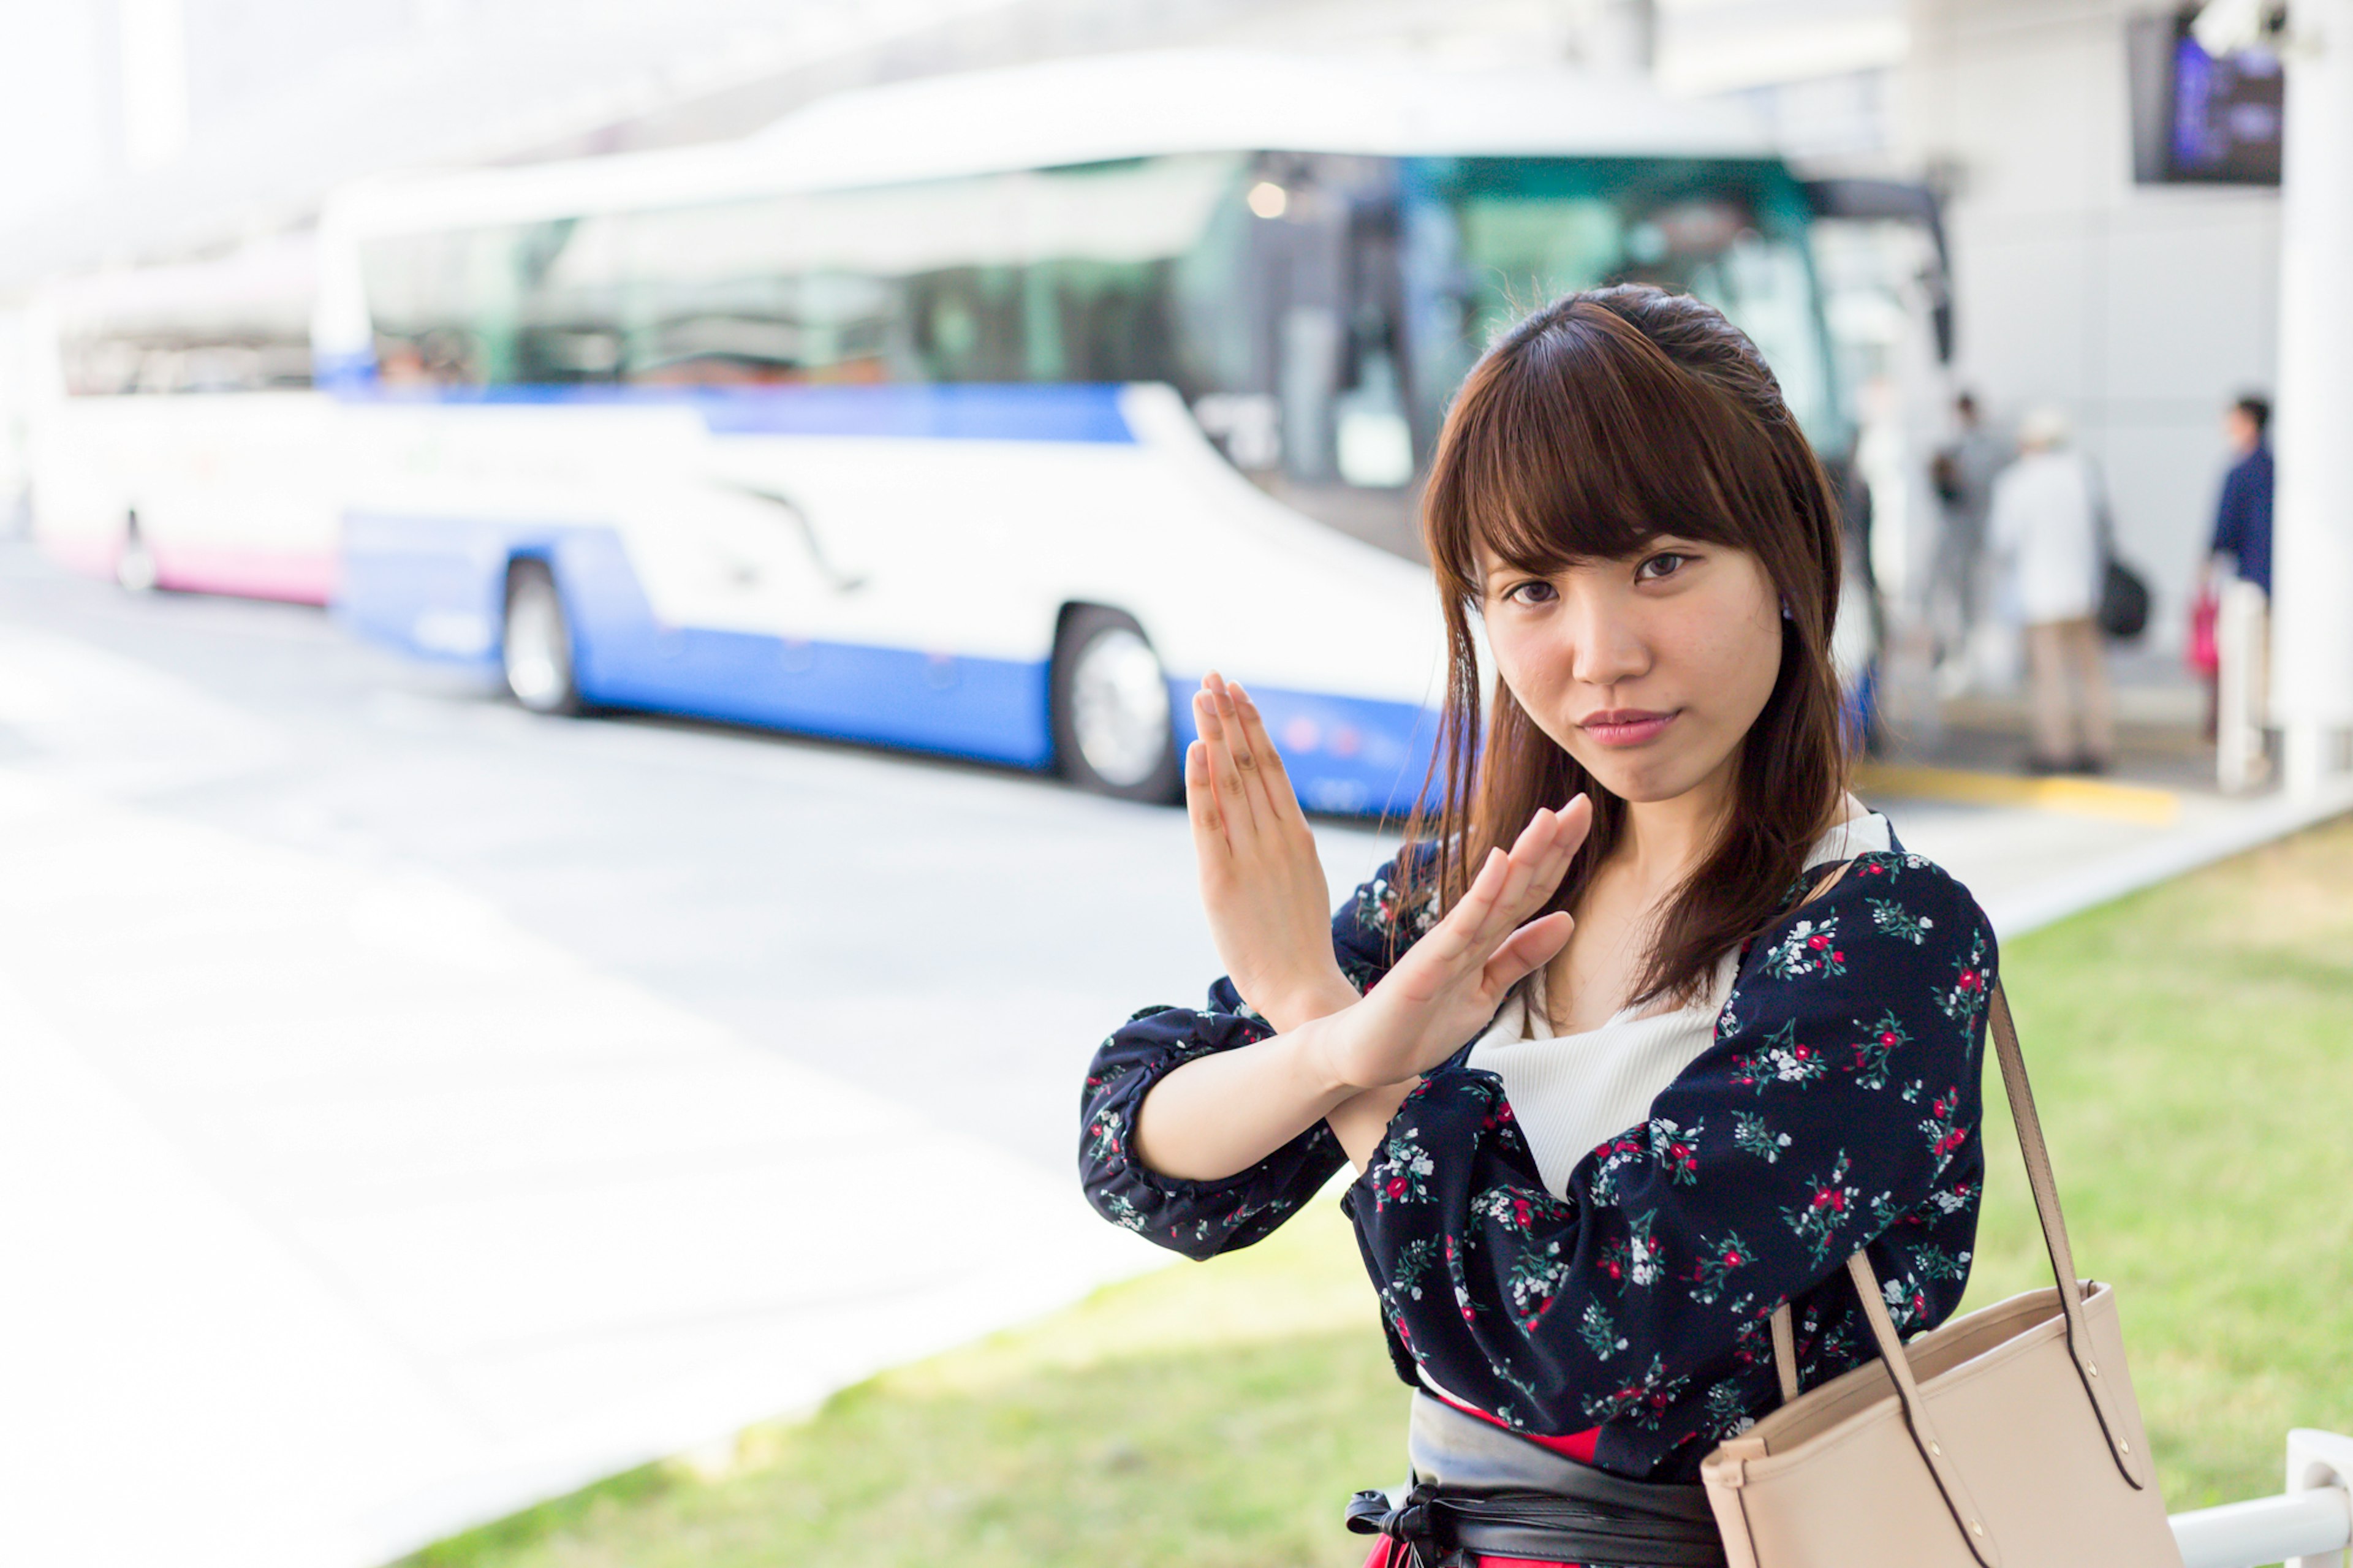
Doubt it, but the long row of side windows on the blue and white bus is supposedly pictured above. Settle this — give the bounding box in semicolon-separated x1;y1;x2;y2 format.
362;156;1243;393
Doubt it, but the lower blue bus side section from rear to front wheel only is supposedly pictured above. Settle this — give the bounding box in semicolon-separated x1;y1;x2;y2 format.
336;513;1054;768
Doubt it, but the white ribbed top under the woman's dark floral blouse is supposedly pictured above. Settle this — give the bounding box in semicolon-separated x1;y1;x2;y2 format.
1468;805;1892;1196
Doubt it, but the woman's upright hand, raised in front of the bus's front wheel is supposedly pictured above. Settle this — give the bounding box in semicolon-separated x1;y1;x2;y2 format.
1184;671;1355;1034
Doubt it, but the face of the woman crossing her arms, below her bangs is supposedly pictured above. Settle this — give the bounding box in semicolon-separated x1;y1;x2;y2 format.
1480;534;1781;803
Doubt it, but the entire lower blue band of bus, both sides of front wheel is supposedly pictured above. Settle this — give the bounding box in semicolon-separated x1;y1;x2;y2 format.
334;513;1435;814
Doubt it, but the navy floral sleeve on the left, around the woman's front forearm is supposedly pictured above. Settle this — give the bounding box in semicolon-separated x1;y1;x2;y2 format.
1078;843;1428;1257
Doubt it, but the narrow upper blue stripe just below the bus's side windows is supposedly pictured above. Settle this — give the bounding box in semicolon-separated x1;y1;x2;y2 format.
332;381;1137;445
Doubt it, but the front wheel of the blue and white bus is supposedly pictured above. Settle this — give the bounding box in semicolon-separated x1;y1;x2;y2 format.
1051;605;1184;803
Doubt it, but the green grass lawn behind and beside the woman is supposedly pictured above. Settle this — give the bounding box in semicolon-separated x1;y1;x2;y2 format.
409;822;2353;1568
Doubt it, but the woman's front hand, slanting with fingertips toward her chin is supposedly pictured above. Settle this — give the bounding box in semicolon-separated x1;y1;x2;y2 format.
1313;796;1593;1088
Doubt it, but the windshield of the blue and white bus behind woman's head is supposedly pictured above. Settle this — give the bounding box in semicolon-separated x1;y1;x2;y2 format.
1400;157;1845;450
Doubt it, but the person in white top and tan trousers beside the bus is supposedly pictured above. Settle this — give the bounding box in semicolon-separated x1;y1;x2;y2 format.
1986;407;2115;772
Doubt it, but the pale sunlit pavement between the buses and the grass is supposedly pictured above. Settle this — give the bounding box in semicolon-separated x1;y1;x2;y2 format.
0;544;2336;1568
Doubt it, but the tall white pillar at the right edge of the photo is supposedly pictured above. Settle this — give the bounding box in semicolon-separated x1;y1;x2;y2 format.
2271;0;2353;793
